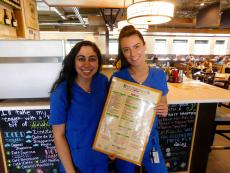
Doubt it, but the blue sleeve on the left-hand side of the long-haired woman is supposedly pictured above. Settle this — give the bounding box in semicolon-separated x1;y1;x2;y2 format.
49;85;68;125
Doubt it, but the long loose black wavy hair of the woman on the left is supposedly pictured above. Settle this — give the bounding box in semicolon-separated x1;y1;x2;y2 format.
50;41;102;105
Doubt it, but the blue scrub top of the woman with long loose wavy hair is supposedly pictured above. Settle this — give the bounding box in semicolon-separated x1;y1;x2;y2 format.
49;74;108;169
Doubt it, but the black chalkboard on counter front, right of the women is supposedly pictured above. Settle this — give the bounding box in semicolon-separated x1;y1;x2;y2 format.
158;103;197;172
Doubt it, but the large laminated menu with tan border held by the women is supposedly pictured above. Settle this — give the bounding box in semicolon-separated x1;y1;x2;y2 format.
93;77;162;165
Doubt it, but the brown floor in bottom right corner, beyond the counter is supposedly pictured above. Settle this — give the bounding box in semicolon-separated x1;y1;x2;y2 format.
206;127;230;173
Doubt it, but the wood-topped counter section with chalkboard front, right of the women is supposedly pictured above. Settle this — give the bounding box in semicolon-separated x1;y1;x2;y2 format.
159;79;230;173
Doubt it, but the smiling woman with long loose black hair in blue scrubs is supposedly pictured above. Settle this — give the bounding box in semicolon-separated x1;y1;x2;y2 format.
49;41;108;173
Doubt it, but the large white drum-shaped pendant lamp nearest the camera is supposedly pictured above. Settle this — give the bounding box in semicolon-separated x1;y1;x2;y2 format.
127;0;174;25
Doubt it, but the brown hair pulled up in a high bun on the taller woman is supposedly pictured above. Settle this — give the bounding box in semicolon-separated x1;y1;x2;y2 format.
118;25;145;69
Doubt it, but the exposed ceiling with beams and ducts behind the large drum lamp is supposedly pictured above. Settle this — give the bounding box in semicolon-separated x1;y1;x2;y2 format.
36;0;230;34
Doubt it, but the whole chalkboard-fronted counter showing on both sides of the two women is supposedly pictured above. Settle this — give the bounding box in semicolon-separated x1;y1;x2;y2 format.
0;79;230;173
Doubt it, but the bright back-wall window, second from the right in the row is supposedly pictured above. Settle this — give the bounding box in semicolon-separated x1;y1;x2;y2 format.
194;40;210;55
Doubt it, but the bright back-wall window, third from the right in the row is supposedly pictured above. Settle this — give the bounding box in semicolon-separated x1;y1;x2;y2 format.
173;40;189;54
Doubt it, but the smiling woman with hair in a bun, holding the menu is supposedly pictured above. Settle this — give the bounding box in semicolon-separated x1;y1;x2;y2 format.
110;25;168;173
